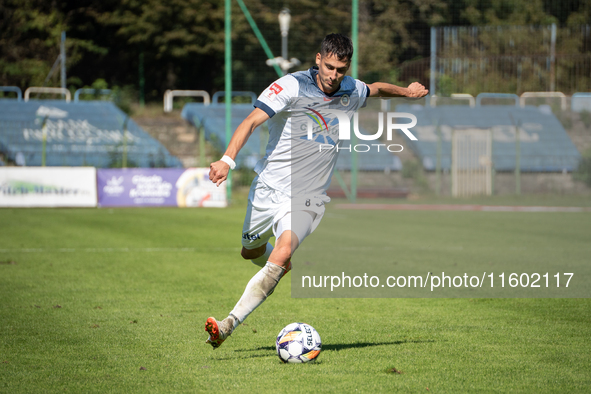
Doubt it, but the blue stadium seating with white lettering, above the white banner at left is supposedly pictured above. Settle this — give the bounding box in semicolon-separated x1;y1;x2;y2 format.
0;100;182;168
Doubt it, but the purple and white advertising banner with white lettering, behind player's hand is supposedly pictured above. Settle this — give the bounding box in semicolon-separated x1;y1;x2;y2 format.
97;168;227;208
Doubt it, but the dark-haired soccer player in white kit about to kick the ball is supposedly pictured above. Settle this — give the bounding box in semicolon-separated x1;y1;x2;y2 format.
205;34;428;348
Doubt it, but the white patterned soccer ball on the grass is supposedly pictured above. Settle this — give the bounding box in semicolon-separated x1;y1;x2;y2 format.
275;323;322;363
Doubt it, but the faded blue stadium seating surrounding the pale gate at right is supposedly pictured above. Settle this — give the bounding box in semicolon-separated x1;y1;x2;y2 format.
396;104;581;172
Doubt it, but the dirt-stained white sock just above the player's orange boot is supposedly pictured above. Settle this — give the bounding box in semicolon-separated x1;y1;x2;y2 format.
230;262;285;328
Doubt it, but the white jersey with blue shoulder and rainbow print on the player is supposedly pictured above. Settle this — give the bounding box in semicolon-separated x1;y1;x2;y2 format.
254;67;369;197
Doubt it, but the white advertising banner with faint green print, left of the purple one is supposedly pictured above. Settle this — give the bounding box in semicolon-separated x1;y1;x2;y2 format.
0;167;97;207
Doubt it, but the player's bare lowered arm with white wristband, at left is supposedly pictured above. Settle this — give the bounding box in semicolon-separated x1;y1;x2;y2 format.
209;108;269;186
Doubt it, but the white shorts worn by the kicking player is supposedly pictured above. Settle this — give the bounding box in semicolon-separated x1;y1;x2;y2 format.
242;176;330;249
